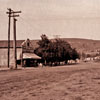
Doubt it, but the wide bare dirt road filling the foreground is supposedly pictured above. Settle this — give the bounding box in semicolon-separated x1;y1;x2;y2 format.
0;63;100;100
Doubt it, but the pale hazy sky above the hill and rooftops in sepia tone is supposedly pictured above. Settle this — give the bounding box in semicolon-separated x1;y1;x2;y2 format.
0;0;100;40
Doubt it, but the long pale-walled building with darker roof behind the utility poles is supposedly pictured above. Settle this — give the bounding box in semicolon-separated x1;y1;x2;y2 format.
0;40;38;67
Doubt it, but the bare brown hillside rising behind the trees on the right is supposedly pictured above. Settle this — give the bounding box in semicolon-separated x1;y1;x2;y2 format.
63;38;100;52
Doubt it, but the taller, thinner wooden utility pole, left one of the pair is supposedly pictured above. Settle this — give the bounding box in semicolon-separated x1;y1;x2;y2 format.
6;8;12;68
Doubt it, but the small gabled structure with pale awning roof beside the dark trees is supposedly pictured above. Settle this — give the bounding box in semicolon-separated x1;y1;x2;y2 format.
17;39;41;67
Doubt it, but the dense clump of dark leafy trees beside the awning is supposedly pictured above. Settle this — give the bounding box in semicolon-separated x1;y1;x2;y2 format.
35;34;80;66
